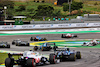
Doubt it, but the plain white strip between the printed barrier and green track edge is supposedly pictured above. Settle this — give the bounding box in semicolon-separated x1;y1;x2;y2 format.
0;28;100;34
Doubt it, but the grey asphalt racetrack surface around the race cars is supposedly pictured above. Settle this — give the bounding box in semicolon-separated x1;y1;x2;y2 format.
0;33;100;67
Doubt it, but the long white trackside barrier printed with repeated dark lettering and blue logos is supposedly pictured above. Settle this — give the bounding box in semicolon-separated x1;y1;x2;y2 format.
0;23;100;30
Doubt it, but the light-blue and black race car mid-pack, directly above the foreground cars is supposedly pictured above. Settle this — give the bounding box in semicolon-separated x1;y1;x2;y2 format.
34;42;58;51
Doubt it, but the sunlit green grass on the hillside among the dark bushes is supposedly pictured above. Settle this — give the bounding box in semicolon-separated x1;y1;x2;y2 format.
9;0;100;21
